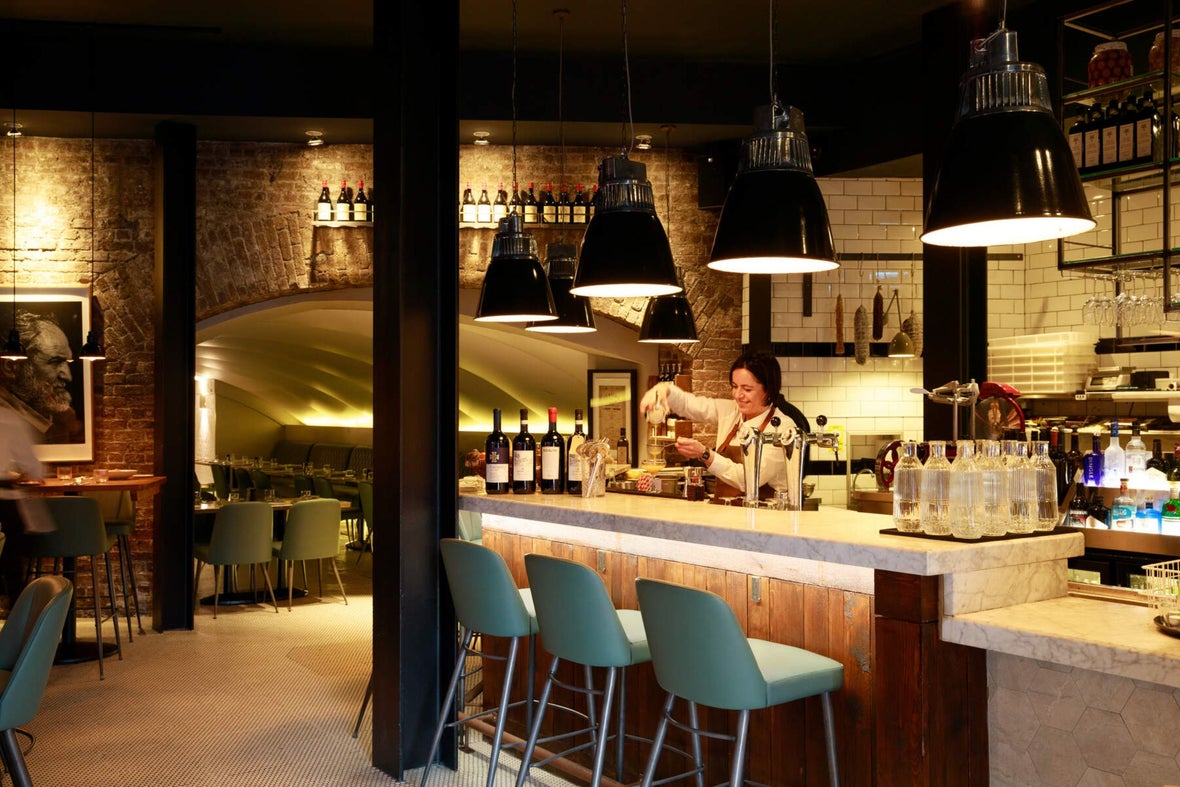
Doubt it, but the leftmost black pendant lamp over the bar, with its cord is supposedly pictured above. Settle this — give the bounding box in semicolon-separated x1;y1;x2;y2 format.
476;0;557;322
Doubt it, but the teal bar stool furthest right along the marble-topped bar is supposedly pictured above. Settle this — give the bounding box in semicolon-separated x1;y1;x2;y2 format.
635;577;844;787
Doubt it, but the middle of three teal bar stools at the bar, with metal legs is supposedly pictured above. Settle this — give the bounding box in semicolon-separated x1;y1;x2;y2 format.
517;555;651;787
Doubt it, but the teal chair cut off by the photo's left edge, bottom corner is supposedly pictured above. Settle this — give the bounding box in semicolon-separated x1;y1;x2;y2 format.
0;576;73;787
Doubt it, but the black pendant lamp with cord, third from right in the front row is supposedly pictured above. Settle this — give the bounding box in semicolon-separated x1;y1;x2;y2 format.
570;0;680;297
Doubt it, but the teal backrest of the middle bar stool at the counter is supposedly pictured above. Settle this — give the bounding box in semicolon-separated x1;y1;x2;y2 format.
524;555;634;667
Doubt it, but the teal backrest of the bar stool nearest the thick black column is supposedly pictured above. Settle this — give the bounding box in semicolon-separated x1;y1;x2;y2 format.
439;538;537;637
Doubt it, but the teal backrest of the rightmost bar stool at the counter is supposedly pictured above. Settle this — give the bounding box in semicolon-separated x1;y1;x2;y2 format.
635;577;767;710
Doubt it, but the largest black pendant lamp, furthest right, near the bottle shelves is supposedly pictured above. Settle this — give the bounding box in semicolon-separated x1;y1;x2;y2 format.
922;2;1095;247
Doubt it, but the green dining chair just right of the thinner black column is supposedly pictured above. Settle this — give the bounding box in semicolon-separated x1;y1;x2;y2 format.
192;501;278;619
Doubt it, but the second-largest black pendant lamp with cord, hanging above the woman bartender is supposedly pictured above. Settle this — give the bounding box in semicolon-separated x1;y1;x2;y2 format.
708;0;839;274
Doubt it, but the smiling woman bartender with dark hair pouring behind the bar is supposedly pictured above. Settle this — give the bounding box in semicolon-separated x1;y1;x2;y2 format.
640;350;811;499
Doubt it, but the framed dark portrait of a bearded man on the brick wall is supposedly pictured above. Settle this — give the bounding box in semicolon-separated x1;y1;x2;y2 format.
0;287;94;461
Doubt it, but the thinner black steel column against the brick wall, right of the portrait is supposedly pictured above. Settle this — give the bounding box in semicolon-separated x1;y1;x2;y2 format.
151;122;197;631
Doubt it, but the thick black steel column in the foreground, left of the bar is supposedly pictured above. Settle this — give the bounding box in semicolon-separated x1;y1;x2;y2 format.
370;2;457;778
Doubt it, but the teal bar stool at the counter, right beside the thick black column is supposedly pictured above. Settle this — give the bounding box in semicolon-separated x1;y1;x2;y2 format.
420;538;538;787
